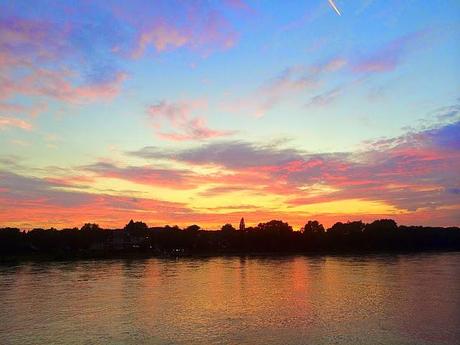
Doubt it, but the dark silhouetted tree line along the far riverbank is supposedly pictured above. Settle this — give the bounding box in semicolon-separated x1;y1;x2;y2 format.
0;219;460;258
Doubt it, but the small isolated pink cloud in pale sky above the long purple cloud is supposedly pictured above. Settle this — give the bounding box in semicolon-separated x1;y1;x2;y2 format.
147;101;236;141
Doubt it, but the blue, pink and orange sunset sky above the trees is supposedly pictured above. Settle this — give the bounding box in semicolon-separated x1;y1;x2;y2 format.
0;0;460;229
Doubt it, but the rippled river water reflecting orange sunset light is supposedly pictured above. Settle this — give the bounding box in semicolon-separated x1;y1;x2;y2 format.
0;253;460;345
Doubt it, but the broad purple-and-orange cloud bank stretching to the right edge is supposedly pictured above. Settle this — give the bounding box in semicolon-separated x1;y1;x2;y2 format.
130;122;460;212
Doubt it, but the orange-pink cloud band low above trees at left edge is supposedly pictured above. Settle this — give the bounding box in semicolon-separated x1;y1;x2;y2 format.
0;171;191;228
